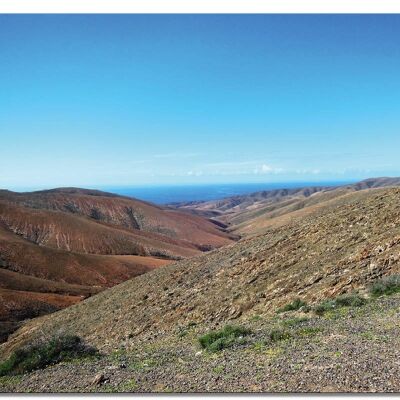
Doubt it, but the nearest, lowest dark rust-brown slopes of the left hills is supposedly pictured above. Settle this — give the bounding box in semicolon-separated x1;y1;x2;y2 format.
0;222;170;340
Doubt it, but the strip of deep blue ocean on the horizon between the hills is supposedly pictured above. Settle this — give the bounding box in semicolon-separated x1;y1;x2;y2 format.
100;181;353;204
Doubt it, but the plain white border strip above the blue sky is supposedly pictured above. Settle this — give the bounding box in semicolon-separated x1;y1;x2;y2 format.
0;0;400;14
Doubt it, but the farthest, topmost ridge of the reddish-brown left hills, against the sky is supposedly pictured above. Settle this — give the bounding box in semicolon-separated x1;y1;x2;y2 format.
0;188;230;248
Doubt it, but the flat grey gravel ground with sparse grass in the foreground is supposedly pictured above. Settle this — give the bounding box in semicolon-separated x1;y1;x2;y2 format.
0;295;400;392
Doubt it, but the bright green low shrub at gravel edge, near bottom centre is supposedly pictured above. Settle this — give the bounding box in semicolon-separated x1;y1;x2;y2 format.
199;325;251;352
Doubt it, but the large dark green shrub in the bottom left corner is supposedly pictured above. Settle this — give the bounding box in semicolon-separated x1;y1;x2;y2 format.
0;335;97;376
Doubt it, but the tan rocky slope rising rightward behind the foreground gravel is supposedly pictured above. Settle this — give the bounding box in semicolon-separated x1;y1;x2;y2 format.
2;188;400;360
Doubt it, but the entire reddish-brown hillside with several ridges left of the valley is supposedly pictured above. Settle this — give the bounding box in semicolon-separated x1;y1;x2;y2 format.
0;189;232;340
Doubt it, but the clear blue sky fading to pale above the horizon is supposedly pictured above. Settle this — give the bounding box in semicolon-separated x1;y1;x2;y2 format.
0;15;400;188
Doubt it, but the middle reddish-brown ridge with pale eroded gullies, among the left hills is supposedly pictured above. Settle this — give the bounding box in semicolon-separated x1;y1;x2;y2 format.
0;200;199;258
